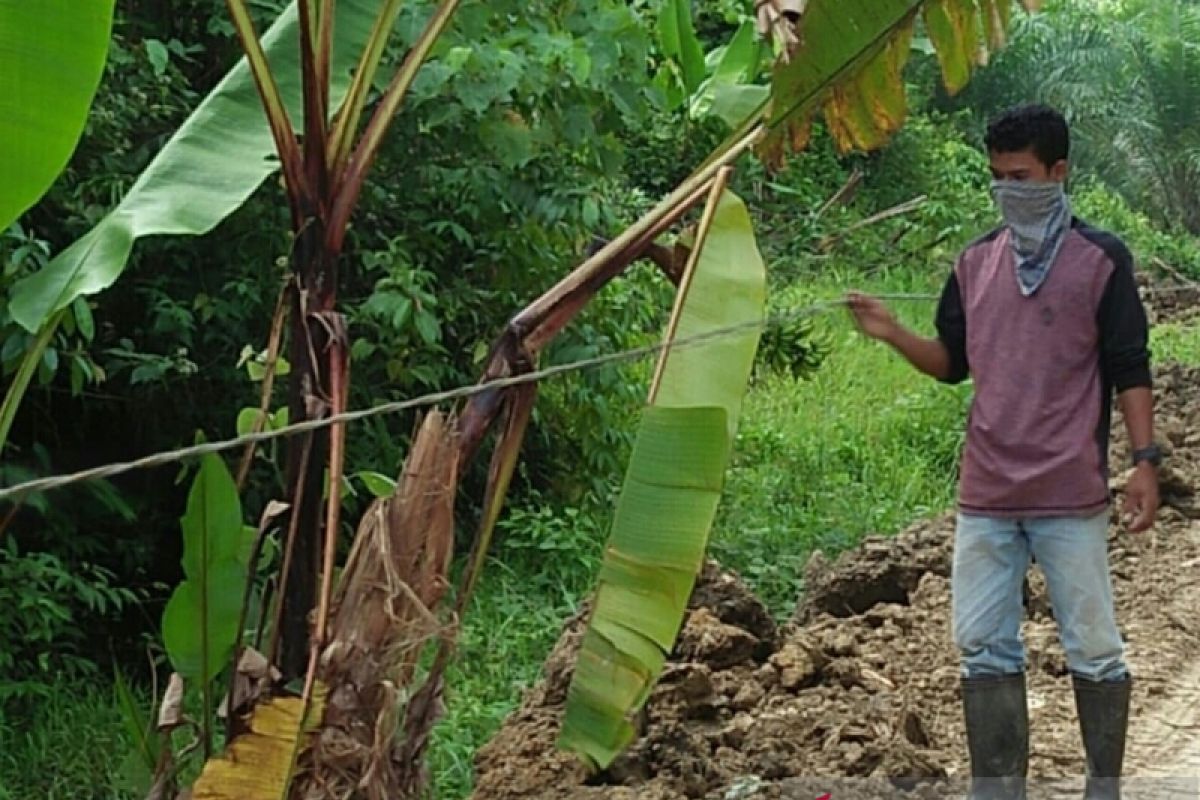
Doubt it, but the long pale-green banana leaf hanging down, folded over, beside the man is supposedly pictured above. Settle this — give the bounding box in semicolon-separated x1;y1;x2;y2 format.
559;192;766;768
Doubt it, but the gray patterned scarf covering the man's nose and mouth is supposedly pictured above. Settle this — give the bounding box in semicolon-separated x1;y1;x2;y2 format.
991;181;1070;297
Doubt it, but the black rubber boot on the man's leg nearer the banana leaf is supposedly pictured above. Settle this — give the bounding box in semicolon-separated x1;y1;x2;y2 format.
962;673;1030;800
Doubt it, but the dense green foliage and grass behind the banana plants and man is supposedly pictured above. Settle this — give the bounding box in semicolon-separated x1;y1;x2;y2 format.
0;0;1200;800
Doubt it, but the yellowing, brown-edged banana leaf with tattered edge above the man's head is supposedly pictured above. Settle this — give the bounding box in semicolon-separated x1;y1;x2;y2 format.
760;0;1040;162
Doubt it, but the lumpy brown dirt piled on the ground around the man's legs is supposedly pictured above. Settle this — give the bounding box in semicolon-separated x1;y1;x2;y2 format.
473;367;1200;800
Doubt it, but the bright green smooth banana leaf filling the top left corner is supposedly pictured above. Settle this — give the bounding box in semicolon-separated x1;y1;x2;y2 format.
0;0;113;230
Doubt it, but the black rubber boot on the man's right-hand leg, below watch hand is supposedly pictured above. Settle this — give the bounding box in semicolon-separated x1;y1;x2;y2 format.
1072;675;1133;800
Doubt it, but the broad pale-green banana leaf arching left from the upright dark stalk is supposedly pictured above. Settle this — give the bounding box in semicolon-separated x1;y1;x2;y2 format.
10;0;379;332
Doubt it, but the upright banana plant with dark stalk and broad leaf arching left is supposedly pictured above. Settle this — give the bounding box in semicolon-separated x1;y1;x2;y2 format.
5;0;458;676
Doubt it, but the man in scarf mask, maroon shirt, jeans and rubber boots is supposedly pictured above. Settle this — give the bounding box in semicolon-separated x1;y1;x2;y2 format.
847;106;1160;800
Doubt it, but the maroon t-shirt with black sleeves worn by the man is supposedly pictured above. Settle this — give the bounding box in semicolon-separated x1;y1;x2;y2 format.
937;219;1151;517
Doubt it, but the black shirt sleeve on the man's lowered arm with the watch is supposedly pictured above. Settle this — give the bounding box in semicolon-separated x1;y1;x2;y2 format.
1097;243;1153;393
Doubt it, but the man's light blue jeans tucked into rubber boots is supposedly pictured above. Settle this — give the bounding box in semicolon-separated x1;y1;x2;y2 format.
950;511;1127;680
